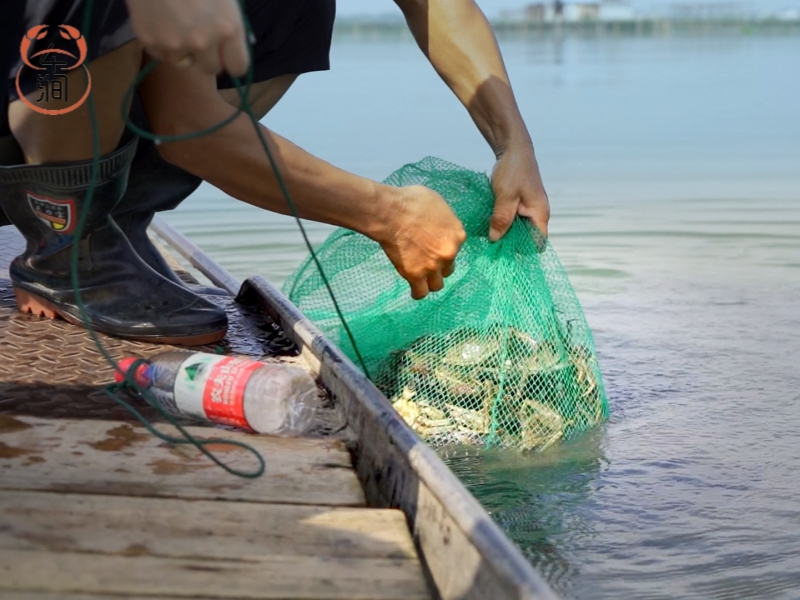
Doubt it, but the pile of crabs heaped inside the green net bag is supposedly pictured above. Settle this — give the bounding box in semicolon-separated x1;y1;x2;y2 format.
379;327;605;451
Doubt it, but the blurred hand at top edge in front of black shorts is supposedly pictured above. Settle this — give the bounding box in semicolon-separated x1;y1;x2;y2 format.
126;0;249;77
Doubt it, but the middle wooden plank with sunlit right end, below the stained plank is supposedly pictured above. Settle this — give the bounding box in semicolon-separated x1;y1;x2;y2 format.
0;491;418;562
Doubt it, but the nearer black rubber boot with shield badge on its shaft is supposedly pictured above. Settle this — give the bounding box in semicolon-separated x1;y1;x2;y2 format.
0;142;228;345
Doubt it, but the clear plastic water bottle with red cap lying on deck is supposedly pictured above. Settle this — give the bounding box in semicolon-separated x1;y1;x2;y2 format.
116;351;321;436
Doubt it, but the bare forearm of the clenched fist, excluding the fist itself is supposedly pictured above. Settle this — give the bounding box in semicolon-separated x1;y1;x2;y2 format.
142;66;396;239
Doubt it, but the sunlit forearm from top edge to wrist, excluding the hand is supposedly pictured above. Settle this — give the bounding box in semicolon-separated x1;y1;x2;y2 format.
396;0;531;156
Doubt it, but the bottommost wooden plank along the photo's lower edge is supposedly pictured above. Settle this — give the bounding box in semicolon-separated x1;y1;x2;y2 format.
0;550;430;600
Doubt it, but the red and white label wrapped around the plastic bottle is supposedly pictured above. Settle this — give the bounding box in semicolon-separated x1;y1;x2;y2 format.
175;354;262;429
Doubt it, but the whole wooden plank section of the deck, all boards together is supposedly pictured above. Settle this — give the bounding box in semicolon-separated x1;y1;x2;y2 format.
0;415;429;600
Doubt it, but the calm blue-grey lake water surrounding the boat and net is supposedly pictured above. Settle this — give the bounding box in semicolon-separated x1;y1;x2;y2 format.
168;29;800;599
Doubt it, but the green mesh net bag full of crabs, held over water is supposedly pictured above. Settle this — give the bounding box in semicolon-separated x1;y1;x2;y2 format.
284;158;608;450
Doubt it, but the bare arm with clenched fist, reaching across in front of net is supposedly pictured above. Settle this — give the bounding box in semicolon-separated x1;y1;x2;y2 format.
141;64;465;298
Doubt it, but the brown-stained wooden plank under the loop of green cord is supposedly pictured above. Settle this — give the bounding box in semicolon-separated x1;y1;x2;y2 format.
0;415;365;506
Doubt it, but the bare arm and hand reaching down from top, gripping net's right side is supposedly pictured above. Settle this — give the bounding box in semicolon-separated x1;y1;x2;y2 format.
395;0;550;239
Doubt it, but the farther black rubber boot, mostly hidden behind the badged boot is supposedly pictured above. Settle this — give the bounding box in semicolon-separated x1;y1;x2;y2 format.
111;140;227;294
